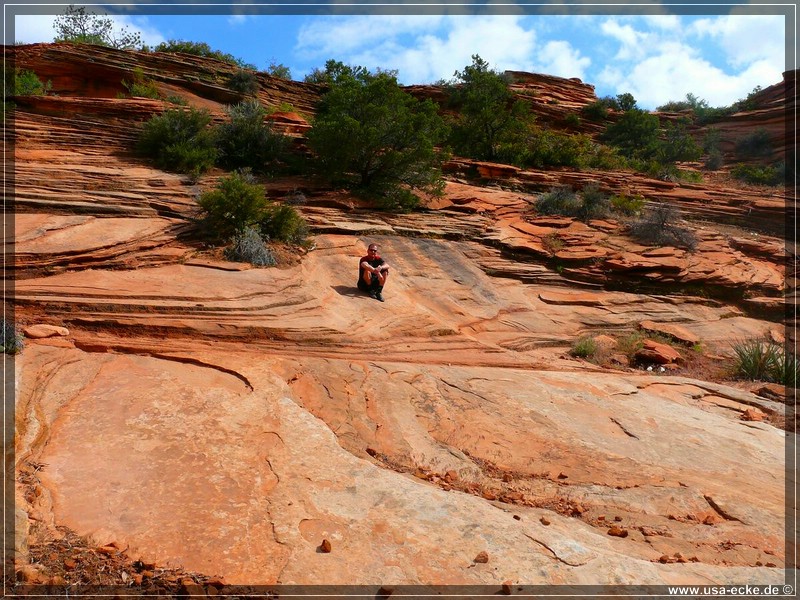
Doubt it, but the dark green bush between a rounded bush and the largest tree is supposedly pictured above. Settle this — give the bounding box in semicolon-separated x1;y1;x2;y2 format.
216;99;288;173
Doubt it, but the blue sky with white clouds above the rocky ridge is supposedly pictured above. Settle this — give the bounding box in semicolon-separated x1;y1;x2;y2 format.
14;3;795;109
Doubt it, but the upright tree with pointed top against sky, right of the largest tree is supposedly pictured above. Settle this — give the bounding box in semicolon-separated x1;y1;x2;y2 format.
447;54;528;160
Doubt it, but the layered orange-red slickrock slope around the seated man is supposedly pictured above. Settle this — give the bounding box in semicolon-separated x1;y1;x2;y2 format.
5;45;793;594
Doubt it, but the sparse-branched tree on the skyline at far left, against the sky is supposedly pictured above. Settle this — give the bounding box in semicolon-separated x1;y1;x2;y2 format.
53;4;142;50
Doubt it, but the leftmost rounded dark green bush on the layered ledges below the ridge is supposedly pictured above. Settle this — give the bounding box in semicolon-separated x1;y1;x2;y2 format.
137;108;217;176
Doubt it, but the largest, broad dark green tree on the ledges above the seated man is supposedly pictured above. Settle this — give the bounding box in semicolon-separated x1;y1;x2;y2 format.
308;61;444;210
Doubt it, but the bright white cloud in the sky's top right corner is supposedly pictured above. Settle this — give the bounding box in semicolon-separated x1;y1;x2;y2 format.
689;15;786;72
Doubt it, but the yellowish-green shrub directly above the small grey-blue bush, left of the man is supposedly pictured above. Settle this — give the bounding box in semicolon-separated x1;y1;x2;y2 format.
197;172;269;240
